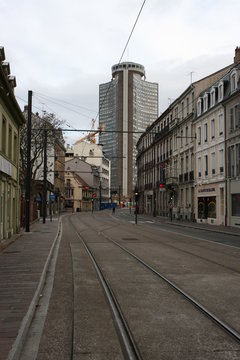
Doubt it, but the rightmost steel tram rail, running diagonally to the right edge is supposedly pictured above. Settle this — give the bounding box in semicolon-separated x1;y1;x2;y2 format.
100;231;240;342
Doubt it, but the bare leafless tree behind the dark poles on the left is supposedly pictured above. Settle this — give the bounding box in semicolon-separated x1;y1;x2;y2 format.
19;109;64;194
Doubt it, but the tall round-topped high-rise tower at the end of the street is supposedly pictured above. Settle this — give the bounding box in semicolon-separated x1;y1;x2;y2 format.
99;62;158;197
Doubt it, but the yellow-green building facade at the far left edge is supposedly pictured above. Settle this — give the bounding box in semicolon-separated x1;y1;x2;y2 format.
0;47;25;240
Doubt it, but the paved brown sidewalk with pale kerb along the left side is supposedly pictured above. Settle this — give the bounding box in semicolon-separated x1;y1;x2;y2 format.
0;218;60;360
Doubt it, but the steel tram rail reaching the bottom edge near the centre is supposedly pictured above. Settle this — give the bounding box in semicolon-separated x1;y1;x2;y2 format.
70;220;142;360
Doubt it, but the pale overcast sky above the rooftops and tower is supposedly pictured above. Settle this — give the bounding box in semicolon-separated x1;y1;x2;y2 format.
0;0;240;143
